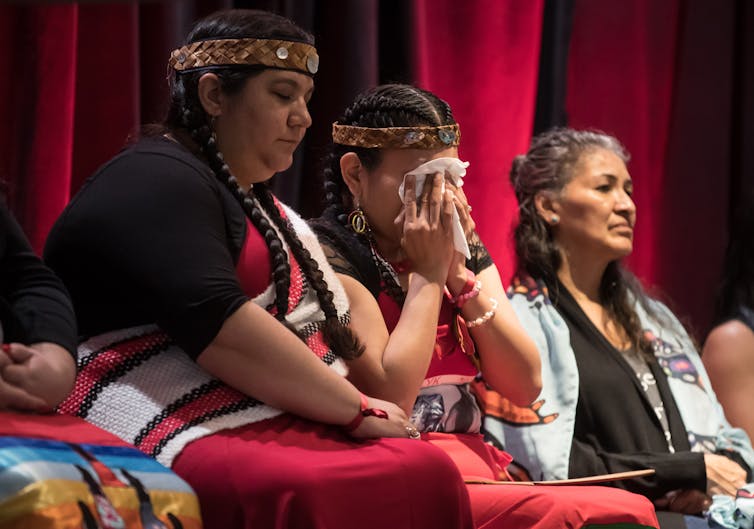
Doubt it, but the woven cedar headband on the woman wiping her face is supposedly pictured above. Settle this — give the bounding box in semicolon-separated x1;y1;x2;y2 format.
332;122;461;149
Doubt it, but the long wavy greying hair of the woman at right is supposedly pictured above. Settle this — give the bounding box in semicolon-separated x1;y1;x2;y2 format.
510;128;655;355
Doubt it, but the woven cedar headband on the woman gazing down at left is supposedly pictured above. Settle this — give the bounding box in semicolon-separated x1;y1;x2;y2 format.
169;38;319;75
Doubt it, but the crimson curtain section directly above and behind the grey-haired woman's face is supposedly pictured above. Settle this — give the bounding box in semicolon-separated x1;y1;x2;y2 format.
566;0;679;284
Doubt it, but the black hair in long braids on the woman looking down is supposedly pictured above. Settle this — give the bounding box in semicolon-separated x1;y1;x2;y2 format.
164;9;364;359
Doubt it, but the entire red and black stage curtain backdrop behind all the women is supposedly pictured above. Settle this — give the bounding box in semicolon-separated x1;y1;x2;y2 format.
0;0;754;338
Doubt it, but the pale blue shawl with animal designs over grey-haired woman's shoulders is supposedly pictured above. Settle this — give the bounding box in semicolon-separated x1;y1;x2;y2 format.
475;278;754;479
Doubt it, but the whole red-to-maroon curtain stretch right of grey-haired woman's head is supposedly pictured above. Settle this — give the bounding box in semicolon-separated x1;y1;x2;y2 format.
566;0;740;334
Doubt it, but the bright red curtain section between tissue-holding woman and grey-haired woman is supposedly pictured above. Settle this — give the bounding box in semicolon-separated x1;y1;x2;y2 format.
414;0;544;280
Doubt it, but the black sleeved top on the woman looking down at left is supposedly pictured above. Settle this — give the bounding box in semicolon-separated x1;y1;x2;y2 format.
44;137;248;358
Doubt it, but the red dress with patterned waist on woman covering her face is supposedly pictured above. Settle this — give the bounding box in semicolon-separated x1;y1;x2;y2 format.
377;292;658;529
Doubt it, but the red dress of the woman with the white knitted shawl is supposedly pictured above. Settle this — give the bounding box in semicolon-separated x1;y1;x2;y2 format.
172;218;472;529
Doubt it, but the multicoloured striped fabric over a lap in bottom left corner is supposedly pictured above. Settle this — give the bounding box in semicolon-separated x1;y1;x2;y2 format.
0;412;202;529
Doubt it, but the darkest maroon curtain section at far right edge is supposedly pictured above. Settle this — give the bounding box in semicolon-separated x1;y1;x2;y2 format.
655;0;736;334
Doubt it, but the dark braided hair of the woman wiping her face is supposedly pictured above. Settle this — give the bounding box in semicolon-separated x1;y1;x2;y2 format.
324;84;456;301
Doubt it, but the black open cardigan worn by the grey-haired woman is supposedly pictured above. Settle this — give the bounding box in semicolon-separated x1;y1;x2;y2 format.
548;276;751;499
